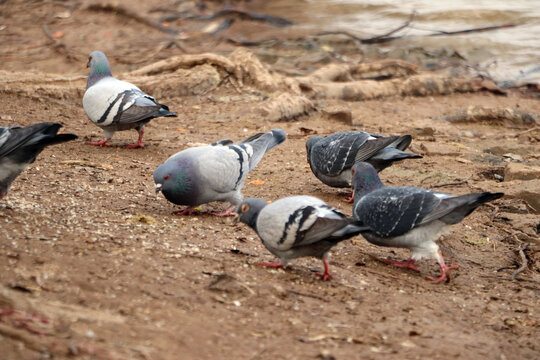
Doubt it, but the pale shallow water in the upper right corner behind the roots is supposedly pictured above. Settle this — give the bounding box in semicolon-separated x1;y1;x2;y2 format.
262;0;540;83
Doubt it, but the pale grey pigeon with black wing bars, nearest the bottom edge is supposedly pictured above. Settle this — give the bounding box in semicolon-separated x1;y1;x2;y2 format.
235;196;366;280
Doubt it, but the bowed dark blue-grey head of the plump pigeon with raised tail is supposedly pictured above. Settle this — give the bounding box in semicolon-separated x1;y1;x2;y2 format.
154;160;199;206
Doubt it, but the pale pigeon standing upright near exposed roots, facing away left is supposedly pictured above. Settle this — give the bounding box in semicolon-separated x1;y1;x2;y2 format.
83;51;176;149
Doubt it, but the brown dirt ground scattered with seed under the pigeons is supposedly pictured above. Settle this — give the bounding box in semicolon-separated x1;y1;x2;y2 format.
0;1;540;360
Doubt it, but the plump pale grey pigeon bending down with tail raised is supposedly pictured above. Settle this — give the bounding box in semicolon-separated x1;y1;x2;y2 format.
154;129;286;216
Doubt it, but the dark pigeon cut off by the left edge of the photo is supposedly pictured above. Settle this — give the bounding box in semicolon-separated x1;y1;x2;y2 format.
0;123;77;199
